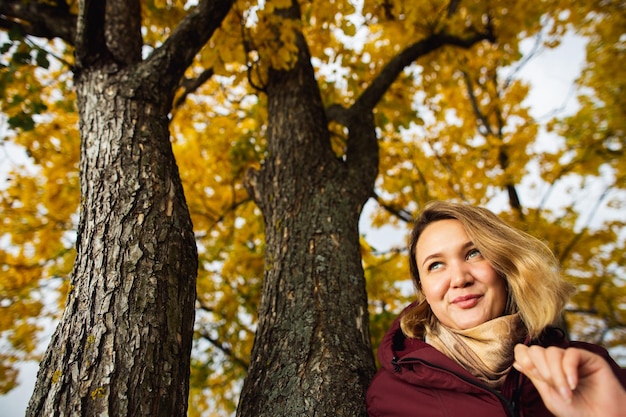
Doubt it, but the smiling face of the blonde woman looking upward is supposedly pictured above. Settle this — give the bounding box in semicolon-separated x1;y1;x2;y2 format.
415;220;506;330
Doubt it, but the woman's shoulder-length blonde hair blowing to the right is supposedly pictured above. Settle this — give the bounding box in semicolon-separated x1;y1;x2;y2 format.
400;201;574;338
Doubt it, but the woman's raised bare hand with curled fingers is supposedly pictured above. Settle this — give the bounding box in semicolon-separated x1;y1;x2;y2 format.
513;344;626;417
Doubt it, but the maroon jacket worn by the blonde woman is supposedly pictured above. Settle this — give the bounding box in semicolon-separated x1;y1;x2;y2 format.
367;310;626;417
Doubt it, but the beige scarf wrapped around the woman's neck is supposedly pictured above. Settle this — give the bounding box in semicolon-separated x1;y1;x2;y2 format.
425;314;526;390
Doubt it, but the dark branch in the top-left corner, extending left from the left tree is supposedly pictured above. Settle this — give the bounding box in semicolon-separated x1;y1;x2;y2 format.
0;0;76;45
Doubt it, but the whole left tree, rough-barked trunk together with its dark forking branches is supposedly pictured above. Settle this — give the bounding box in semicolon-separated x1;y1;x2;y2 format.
8;0;232;417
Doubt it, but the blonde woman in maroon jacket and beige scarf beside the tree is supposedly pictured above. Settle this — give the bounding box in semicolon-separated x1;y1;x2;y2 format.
367;202;626;417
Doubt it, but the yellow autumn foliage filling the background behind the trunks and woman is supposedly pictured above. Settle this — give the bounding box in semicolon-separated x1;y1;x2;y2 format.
0;0;626;416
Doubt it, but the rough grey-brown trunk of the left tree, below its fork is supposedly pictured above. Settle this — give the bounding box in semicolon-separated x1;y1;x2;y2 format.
27;63;197;417
